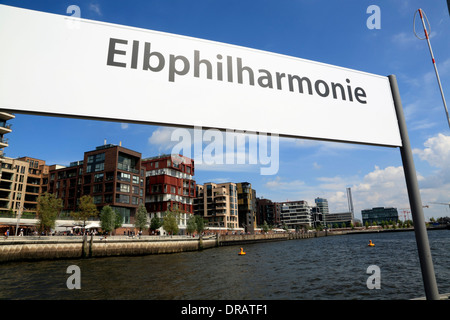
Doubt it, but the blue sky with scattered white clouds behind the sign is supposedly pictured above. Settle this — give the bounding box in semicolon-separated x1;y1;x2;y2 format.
0;0;450;218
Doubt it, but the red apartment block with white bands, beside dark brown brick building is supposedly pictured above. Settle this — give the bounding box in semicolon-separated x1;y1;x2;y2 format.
142;154;196;233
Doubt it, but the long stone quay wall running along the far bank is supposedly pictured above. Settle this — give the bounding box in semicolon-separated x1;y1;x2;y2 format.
0;228;442;263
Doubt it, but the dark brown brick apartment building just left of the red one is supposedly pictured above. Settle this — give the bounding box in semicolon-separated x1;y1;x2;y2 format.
43;144;145;224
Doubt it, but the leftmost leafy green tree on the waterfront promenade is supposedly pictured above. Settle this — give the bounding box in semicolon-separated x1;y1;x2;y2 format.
37;192;63;234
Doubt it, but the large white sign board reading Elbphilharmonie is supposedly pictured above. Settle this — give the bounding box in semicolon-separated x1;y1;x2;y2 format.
0;5;401;146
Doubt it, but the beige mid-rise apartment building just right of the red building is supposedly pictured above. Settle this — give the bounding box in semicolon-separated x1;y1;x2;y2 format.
194;182;240;230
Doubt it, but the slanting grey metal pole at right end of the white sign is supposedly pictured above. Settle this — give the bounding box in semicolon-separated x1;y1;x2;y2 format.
389;75;439;300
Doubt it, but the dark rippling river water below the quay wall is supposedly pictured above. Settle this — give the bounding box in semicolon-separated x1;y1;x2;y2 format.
0;230;450;300
